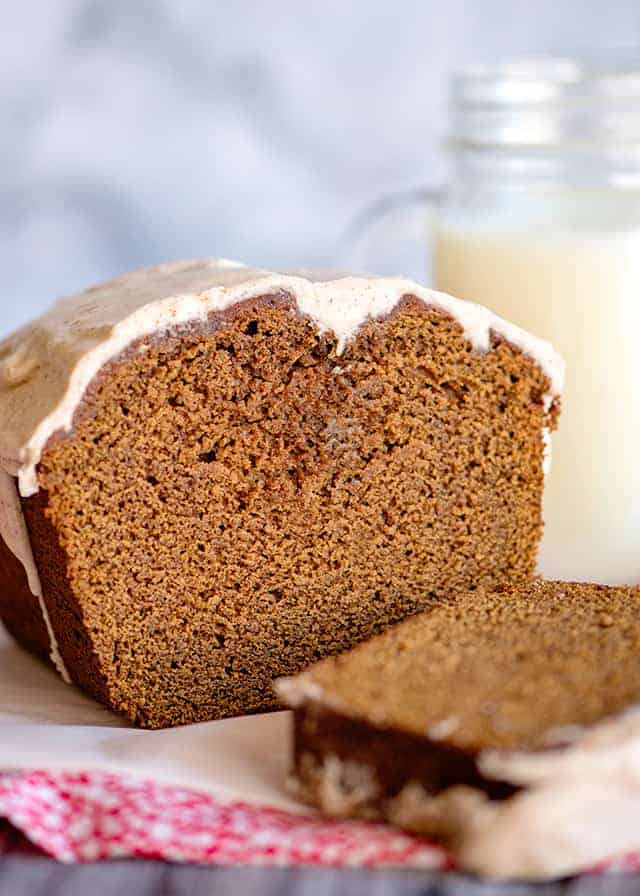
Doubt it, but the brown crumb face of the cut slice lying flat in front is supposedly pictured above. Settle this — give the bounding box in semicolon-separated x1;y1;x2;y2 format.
281;581;640;754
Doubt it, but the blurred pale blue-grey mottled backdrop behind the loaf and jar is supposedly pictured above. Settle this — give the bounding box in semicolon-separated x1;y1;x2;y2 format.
0;0;640;335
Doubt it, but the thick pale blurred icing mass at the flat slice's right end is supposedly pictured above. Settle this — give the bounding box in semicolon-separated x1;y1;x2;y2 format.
450;708;640;877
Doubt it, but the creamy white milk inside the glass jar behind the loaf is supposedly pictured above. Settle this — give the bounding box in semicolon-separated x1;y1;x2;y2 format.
434;205;640;584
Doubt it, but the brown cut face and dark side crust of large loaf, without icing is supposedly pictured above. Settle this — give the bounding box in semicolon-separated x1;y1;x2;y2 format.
6;295;557;727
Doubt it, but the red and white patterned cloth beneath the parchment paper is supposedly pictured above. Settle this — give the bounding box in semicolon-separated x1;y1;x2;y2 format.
0;771;451;869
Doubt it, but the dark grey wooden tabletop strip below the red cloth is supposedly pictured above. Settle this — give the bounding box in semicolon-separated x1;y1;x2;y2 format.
0;856;640;896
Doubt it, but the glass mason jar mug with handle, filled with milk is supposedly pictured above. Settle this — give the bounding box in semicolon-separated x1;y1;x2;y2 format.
351;59;640;584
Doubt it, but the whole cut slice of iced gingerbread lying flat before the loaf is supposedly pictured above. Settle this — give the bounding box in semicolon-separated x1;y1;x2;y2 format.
276;581;640;878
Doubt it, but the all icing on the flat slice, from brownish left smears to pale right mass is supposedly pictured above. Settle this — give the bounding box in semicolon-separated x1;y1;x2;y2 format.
297;694;640;880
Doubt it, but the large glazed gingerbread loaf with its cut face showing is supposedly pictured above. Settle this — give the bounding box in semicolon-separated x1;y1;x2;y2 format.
0;261;562;727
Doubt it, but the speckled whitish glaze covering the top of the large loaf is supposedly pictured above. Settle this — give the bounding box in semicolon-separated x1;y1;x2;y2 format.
0;259;564;496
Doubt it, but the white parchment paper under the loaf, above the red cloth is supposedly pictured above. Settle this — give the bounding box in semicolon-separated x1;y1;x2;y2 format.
0;626;309;812
